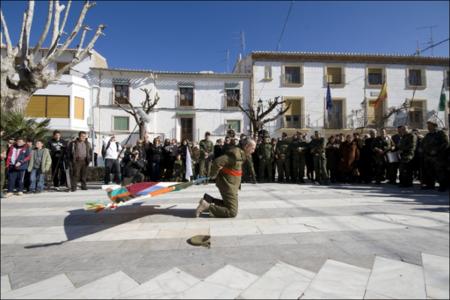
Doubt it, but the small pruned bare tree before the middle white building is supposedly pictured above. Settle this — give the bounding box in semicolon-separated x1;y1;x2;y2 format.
115;89;160;139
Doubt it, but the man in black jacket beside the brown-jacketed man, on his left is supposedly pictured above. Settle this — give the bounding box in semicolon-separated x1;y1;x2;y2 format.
47;130;67;189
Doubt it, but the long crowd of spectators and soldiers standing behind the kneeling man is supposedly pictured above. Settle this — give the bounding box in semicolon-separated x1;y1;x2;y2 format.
1;120;450;197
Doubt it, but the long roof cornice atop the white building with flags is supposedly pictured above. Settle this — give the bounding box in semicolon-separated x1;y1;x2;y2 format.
251;51;450;67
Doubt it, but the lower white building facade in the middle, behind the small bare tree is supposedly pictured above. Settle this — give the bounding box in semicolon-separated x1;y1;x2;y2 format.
90;68;251;150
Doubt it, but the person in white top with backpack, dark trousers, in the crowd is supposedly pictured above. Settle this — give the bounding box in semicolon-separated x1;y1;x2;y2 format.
102;135;122;184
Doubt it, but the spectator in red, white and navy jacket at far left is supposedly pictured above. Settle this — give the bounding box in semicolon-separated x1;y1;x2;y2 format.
5;138;31;197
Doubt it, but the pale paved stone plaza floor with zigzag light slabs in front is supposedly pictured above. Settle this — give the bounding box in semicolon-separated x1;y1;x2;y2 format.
1;184;449;299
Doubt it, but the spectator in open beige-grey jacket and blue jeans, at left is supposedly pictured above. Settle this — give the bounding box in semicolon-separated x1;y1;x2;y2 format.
28;140;52;193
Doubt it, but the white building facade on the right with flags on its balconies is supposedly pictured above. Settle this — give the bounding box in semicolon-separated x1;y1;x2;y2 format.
234;52;450;135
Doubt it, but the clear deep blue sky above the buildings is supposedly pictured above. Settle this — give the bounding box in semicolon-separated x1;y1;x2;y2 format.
2;0;449;72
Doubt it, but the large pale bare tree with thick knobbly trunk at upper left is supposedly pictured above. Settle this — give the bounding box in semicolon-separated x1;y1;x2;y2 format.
1;0;105;112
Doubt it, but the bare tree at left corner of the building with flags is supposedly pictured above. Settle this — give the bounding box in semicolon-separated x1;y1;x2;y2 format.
234;96;291;138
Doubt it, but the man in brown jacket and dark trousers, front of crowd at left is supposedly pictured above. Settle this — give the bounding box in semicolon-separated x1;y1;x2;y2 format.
67;131;92;192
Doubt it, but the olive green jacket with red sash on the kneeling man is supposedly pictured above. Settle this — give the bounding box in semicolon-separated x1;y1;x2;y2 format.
211;147;249;192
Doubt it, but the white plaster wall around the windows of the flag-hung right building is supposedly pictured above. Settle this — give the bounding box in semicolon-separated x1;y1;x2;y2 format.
253;61;449;132
